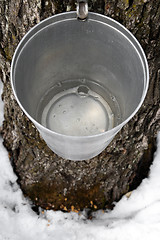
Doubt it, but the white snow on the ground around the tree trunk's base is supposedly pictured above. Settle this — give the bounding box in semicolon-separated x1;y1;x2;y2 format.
0;79;160;240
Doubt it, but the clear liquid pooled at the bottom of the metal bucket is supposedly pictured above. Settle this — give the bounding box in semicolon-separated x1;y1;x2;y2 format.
38;80;120;136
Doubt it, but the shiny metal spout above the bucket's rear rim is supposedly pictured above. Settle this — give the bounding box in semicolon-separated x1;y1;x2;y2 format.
77;0;88;20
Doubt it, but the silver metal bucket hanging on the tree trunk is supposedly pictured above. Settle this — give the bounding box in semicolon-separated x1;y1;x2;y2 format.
11;12;149;160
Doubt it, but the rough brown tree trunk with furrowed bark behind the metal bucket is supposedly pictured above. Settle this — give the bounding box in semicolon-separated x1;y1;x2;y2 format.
0;0;160;210
